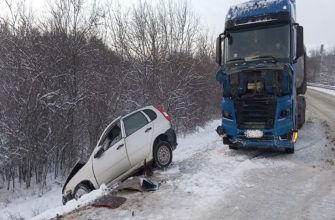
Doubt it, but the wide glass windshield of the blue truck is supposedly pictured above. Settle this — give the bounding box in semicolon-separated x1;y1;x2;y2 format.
225;24;290;63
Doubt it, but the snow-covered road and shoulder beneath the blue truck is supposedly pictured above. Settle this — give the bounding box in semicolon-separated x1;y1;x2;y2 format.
56;90;335;219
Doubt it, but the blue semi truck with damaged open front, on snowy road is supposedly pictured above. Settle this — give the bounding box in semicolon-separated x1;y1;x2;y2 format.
216;0;307;153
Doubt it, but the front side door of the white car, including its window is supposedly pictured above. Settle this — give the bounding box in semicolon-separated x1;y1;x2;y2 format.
93;120;130;185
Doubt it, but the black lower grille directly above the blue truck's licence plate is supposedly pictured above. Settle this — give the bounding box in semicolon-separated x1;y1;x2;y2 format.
235;96;277;129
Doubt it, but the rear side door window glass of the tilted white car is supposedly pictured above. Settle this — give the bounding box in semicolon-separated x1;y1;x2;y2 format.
123;112;148;137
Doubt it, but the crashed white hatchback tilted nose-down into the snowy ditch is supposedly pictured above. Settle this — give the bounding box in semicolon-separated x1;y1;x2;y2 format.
62;106;177;204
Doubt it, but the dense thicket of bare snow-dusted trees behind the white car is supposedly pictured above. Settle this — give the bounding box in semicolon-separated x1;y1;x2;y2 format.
0;0;220;189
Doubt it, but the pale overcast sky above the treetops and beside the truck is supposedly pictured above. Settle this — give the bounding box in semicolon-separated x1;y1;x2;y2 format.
0;0;335;49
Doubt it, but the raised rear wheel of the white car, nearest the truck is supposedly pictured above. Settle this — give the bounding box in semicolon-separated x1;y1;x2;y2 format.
154;141;172;169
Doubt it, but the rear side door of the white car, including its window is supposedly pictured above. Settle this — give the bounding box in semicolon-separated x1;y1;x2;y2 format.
123;111;153;167
